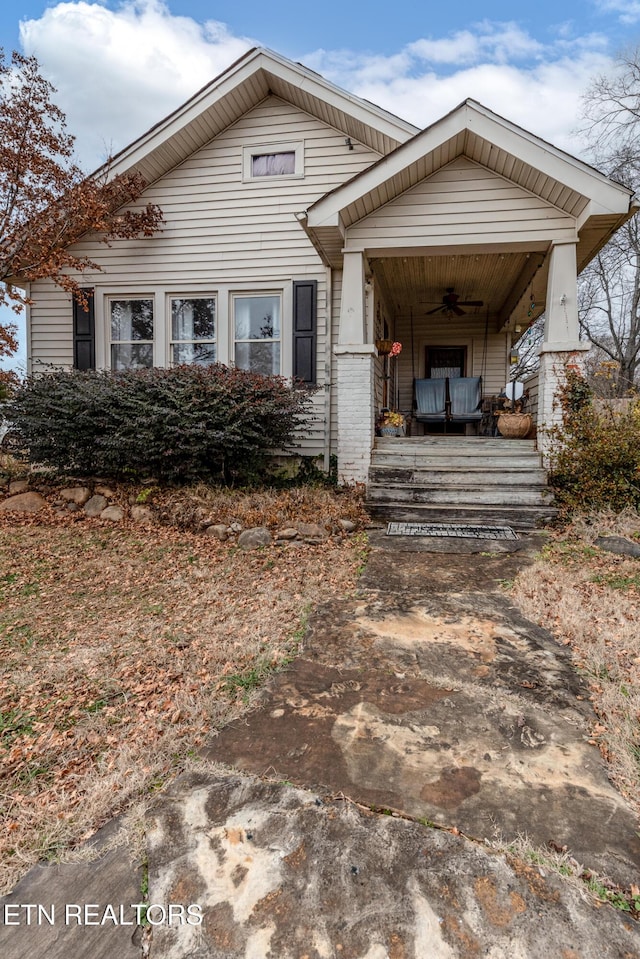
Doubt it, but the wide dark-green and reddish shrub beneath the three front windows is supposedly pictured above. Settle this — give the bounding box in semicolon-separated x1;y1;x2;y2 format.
11;365;310;484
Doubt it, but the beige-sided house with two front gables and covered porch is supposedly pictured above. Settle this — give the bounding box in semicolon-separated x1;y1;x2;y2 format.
22;49;637;492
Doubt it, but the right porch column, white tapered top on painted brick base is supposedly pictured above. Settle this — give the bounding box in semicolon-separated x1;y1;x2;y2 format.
538;243;589;465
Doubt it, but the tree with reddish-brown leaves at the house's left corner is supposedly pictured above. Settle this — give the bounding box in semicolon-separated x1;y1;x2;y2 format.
0;49;162;376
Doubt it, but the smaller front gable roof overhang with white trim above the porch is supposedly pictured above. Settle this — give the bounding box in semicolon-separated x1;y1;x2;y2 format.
301;99;637;265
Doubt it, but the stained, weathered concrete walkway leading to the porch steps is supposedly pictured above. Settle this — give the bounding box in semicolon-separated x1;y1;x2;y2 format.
0;533;640;959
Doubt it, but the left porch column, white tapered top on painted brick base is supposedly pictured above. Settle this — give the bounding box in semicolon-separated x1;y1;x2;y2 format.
334;253;376;483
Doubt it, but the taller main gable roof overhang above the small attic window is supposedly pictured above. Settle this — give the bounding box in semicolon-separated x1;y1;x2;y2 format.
105;47;418;183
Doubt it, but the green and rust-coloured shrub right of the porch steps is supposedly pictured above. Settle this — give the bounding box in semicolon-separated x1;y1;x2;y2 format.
550;370;640;512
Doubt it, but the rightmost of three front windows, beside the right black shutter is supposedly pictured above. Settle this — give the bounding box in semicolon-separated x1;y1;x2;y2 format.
233;293;282;376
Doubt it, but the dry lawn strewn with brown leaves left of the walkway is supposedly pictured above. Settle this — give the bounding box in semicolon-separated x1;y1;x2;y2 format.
0;490;364;891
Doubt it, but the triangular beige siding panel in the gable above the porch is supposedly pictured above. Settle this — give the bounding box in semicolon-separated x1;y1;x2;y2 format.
346;157;576;249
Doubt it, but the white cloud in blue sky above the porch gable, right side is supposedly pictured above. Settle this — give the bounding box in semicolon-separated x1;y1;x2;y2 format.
304;21;612;153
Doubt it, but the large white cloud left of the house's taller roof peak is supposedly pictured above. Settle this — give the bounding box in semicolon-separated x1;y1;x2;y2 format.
20;0;254;168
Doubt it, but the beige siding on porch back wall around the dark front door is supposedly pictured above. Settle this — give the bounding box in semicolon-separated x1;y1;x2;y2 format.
395;316;508;411
